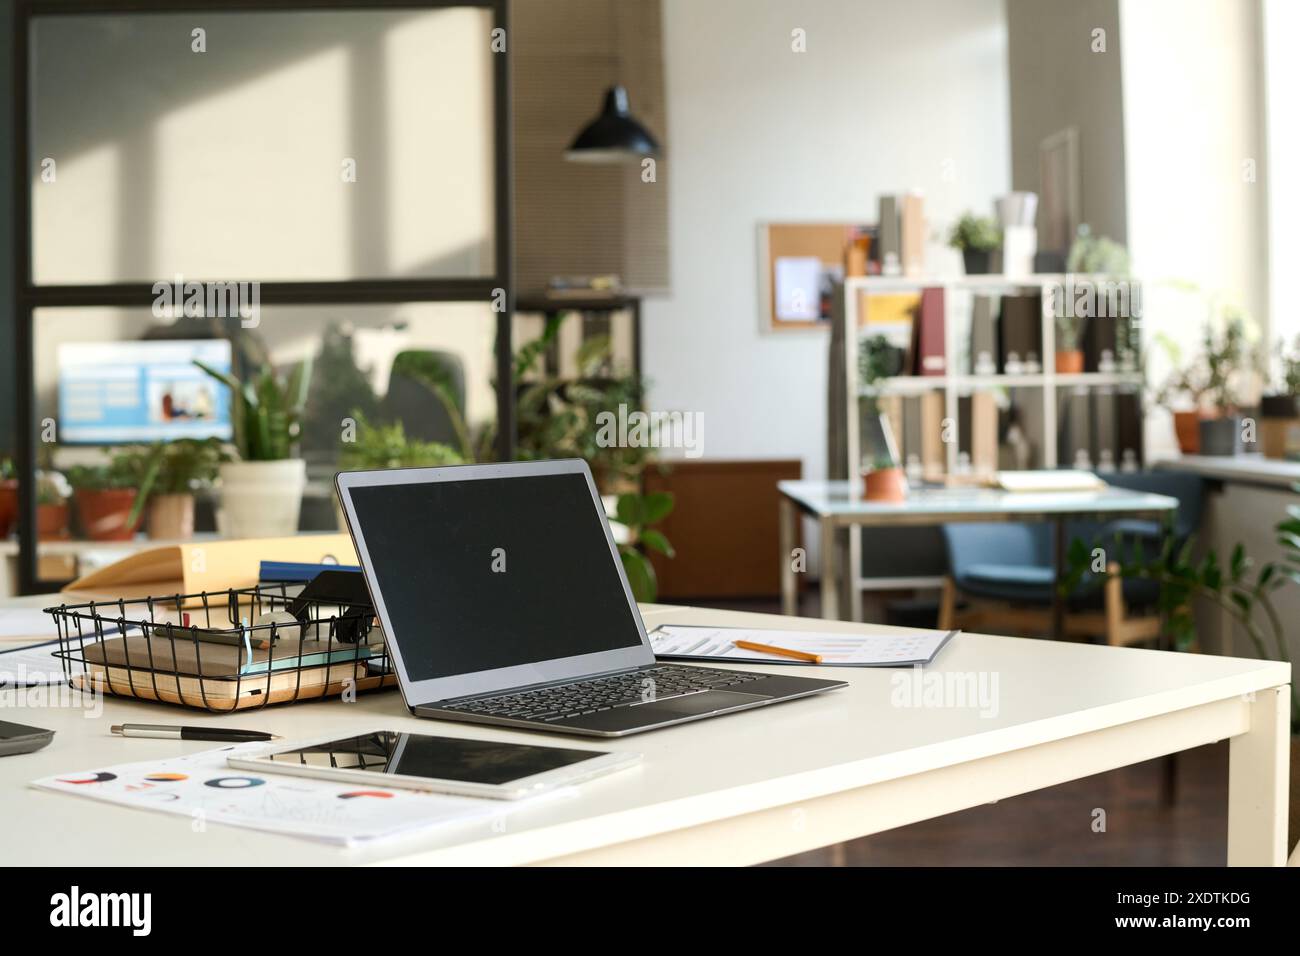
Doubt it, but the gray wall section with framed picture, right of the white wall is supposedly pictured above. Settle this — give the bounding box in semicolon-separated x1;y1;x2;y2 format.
1006;0;1128;242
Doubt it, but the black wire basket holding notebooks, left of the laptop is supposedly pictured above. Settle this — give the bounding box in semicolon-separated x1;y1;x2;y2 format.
46;584;397;713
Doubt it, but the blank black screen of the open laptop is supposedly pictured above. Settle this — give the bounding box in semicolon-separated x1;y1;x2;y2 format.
351;475;641;680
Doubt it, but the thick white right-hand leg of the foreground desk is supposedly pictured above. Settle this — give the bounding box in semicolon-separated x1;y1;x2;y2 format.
1227;687;1291;866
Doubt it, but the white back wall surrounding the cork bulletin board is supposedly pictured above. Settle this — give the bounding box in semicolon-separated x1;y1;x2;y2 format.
644;0;1010;477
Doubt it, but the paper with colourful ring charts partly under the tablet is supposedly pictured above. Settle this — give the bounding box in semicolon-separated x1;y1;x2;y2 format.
31;744;573;845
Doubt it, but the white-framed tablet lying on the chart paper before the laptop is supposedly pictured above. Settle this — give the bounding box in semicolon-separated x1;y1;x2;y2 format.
226;731;641;800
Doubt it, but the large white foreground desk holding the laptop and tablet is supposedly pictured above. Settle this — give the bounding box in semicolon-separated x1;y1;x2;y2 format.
0;598;1290;865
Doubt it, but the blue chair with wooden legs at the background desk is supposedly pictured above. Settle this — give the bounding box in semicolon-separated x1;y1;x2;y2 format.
940;472;1204;645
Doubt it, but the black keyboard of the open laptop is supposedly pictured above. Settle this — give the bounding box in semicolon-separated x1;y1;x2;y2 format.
438;665;767;721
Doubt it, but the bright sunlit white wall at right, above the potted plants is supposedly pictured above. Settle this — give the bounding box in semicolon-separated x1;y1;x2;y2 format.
1119;0;1268;458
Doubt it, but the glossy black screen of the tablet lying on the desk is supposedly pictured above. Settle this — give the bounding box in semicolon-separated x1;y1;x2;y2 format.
268;731;605;784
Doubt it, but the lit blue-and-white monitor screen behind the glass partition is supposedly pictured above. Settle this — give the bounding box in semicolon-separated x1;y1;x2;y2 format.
59;338;231;445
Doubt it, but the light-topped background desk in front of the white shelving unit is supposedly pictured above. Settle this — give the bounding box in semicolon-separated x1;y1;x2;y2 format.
776;481;1178;637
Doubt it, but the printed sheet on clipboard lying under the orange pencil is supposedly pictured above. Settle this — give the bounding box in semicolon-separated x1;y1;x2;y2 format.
650;624;957;667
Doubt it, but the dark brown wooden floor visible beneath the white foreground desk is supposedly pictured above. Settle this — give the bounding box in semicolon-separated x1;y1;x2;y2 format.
683;597;1227;866
